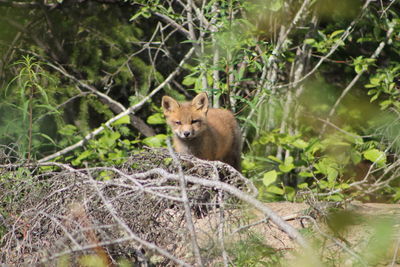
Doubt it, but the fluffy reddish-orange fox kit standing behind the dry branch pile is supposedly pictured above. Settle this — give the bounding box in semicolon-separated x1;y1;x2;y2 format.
162;93;242;171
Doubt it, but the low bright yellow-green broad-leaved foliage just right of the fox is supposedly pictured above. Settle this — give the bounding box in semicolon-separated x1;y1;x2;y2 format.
247;130;394;201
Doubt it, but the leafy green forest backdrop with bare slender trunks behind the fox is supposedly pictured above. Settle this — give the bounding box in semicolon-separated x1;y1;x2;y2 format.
0;0;400;266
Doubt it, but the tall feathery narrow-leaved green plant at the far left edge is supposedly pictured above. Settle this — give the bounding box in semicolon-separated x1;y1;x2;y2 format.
0;56;61;160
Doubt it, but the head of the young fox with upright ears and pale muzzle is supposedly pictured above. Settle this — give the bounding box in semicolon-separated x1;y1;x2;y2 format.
162;93;208;140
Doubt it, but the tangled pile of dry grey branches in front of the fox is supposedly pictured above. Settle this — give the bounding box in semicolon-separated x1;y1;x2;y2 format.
0;150;272;266
